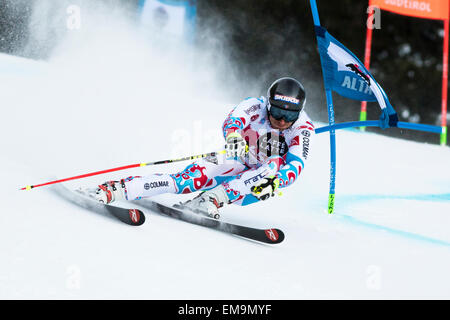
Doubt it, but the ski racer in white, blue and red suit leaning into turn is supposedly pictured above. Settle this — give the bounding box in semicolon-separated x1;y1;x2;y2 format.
94;77;314;219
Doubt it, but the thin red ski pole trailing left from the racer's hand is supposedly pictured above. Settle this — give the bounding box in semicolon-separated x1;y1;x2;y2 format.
20;150;226;190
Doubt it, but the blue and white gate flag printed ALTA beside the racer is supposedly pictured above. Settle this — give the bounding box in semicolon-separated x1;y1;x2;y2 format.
315;26;398;128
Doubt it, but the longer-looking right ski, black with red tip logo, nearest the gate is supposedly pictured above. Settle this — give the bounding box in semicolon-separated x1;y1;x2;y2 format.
134;199;284;244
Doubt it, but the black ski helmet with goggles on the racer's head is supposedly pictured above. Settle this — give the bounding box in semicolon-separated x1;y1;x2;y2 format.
267;77;306;122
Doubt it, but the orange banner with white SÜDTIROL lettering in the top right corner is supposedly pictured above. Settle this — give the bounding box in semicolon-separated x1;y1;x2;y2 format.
370;0;449;20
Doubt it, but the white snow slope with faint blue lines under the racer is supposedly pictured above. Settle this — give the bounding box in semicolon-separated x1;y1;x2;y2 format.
0;45;450;299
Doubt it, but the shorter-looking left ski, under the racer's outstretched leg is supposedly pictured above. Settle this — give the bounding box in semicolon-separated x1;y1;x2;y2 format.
52;184;145;226
